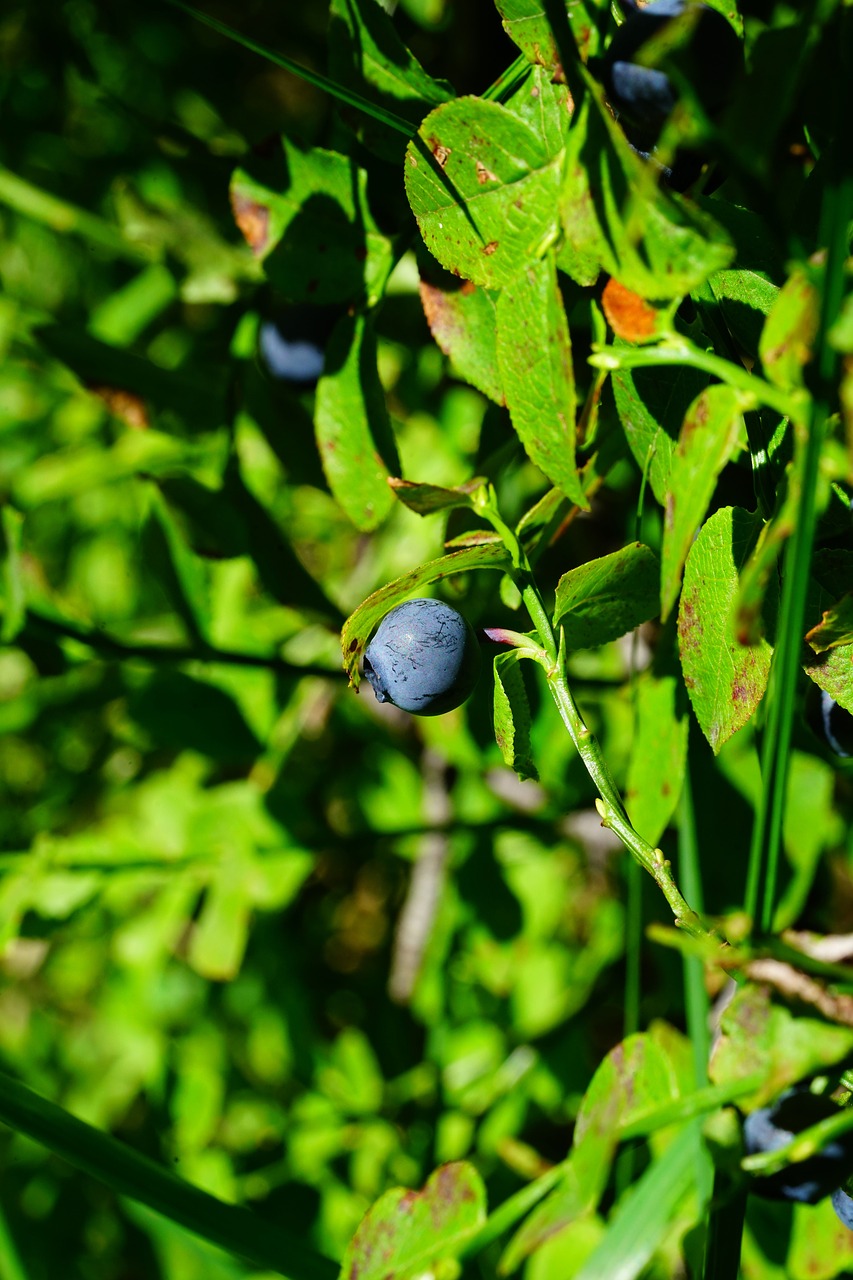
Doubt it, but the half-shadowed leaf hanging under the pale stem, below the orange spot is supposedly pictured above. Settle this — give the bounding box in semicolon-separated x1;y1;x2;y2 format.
611;358;708;506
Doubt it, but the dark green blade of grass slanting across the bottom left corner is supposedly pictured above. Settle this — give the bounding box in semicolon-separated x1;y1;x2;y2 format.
0;1074;338;1280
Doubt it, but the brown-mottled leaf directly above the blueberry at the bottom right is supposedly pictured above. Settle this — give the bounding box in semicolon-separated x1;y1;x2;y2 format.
710;982;853;1111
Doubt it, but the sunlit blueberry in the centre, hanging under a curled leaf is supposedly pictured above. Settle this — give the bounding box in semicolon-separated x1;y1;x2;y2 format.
364;599;480;716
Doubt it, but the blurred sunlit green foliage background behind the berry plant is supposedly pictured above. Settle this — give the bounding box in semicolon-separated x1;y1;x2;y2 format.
0;0;853;1280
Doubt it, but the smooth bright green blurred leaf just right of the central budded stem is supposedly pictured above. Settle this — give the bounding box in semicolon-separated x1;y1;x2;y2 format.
625;672;689;847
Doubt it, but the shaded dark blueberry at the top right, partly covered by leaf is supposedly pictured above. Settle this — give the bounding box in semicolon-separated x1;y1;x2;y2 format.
603;0;743;150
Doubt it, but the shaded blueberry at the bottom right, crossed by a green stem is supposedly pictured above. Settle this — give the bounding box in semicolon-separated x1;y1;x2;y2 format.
743;1088;853;1204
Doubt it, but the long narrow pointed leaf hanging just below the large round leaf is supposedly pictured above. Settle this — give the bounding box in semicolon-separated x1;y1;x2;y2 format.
497;253;589;508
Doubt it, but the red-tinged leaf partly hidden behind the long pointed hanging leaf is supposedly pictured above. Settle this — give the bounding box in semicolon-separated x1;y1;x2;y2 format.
420;272;503;404
